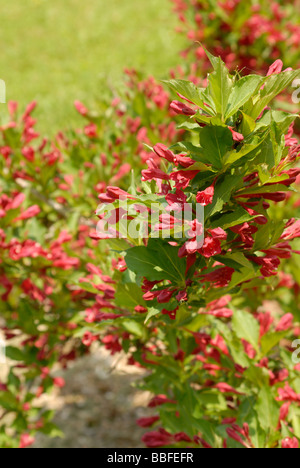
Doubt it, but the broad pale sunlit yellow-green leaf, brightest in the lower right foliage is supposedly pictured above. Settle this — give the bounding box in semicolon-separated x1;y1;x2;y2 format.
232;310;260;350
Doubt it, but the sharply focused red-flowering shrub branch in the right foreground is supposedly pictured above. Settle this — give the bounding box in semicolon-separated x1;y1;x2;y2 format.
94;54;300;448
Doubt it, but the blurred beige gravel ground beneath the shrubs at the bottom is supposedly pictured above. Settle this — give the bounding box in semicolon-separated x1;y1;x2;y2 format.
34;350;150;448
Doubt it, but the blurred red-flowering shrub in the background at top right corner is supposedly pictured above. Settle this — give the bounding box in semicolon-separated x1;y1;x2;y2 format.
172;0;300;74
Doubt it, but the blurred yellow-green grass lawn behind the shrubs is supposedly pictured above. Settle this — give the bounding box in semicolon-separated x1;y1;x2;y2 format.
0;0;182;135
